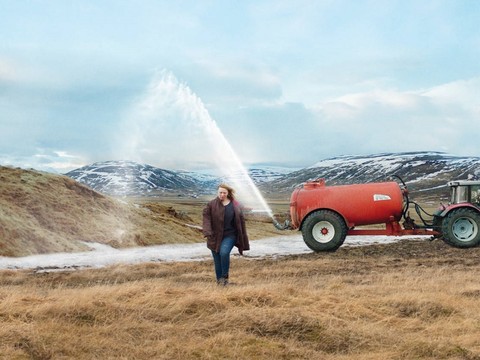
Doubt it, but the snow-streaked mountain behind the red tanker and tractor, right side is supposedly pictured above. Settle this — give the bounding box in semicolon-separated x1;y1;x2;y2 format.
261;152;480;195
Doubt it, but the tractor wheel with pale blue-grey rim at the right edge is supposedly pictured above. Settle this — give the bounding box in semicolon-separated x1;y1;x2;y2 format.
442;208;480;248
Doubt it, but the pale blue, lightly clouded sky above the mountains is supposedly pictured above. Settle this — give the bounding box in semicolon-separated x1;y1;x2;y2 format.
0;0;480;172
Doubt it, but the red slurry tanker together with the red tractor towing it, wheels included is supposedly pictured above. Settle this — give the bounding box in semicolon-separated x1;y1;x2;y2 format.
274;179;480;251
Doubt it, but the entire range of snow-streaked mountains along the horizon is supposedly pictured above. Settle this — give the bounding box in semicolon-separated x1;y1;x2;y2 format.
66;152;480;200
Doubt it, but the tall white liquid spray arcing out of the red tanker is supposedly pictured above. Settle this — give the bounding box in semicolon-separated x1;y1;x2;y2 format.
118;71;273;218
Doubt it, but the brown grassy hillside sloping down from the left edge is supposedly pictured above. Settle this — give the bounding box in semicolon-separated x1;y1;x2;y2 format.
0;167;202;256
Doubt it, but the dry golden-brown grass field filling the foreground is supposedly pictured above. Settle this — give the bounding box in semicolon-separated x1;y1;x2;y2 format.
0;241;480;360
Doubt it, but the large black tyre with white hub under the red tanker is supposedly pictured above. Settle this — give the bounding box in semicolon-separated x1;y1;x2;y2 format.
302;210;348;251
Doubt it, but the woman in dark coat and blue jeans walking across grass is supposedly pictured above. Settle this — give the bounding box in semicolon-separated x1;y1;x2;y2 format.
203;184;250;286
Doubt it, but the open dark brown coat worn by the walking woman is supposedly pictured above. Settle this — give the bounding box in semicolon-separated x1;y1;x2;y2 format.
203;197;250;254
